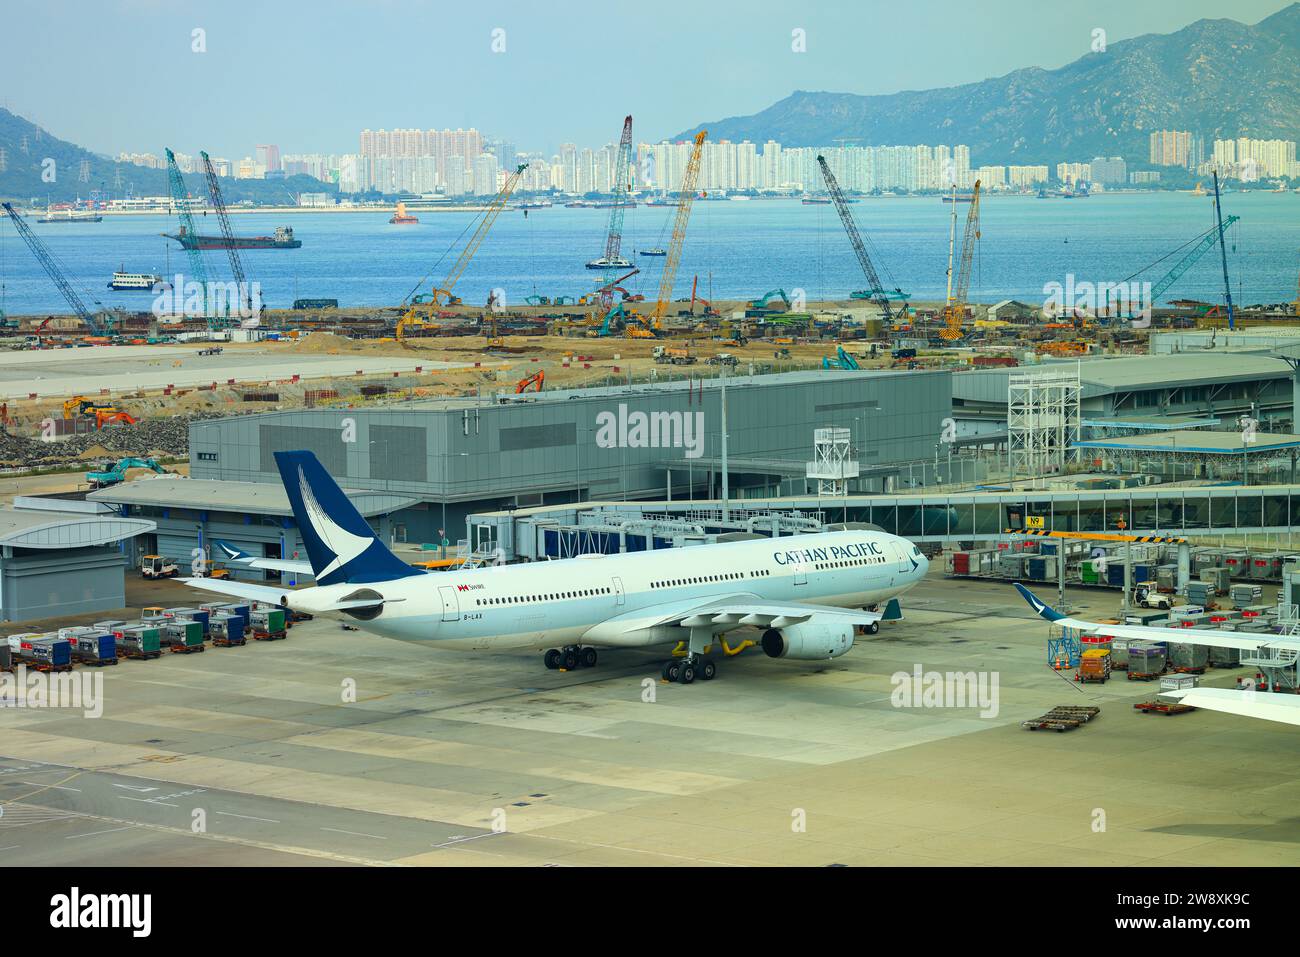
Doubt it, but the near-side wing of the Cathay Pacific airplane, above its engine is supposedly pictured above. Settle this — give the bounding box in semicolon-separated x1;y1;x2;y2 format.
584;593;884;644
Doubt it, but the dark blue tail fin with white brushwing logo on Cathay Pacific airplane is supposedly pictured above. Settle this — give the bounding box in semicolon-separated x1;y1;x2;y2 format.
276;451;423;585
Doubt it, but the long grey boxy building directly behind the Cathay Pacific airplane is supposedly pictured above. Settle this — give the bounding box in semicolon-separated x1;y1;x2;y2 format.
87;371;952;560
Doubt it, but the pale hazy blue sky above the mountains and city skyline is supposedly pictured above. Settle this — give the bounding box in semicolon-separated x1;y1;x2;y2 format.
0;0;1287;157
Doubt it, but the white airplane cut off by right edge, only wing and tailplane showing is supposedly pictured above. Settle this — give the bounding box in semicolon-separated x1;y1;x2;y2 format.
1015;583;1300;724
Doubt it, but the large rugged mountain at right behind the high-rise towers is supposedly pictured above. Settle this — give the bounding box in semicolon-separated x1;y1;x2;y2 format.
675;3;1300;165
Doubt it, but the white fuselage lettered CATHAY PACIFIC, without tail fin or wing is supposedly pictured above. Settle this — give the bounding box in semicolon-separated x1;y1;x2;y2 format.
285;531;928;649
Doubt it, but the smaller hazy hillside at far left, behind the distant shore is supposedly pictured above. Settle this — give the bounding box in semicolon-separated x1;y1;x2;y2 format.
0;108;334;205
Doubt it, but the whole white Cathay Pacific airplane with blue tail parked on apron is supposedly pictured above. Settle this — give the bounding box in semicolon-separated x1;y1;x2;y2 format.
185;451;930;684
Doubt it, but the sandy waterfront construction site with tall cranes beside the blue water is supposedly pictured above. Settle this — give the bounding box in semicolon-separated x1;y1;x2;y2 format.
0;122;1300;486
